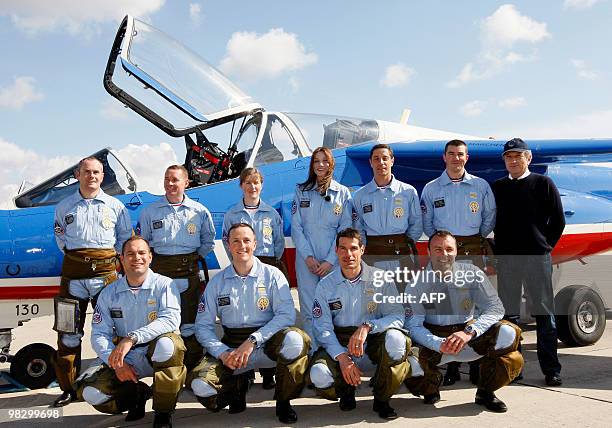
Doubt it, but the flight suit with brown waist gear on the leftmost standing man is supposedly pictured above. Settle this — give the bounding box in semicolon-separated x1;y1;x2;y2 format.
54;189;132;392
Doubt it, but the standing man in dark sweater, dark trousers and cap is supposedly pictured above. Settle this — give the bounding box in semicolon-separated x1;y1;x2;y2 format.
492;138;565;386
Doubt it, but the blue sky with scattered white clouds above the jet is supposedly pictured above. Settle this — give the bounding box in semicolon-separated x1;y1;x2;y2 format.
0;0;612;201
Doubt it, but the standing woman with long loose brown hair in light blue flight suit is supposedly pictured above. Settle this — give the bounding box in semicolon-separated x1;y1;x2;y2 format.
291;147;352;352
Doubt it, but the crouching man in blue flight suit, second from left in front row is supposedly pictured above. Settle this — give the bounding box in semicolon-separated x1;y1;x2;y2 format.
187;223;310;423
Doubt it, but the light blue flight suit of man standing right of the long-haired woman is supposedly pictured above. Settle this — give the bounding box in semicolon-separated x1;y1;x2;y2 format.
353;177;423;270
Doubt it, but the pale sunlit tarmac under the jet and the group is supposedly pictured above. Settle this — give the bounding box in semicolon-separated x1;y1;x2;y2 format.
0;290;612;428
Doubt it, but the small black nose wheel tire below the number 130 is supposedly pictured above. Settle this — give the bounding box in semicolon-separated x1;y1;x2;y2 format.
11;343;55;389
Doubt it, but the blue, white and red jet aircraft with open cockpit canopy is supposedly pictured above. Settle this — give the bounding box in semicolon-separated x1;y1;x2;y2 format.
0;16;612;388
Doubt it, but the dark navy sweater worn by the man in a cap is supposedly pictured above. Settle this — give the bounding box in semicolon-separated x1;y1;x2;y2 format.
492;172;565;255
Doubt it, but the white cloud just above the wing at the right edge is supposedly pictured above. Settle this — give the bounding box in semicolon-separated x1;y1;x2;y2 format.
496;109;612;138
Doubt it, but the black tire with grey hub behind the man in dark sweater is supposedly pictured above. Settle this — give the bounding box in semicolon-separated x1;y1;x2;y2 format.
555;286;606;346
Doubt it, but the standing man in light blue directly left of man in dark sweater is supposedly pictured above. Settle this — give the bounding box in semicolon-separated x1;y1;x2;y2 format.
421;140;495;385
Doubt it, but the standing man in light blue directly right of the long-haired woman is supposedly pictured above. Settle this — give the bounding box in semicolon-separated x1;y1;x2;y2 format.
353;144;423;269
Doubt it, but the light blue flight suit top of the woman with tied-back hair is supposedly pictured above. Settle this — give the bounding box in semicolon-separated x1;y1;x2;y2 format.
223;200;285;259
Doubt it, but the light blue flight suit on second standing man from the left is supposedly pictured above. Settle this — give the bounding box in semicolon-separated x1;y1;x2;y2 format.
136;195;215;346
